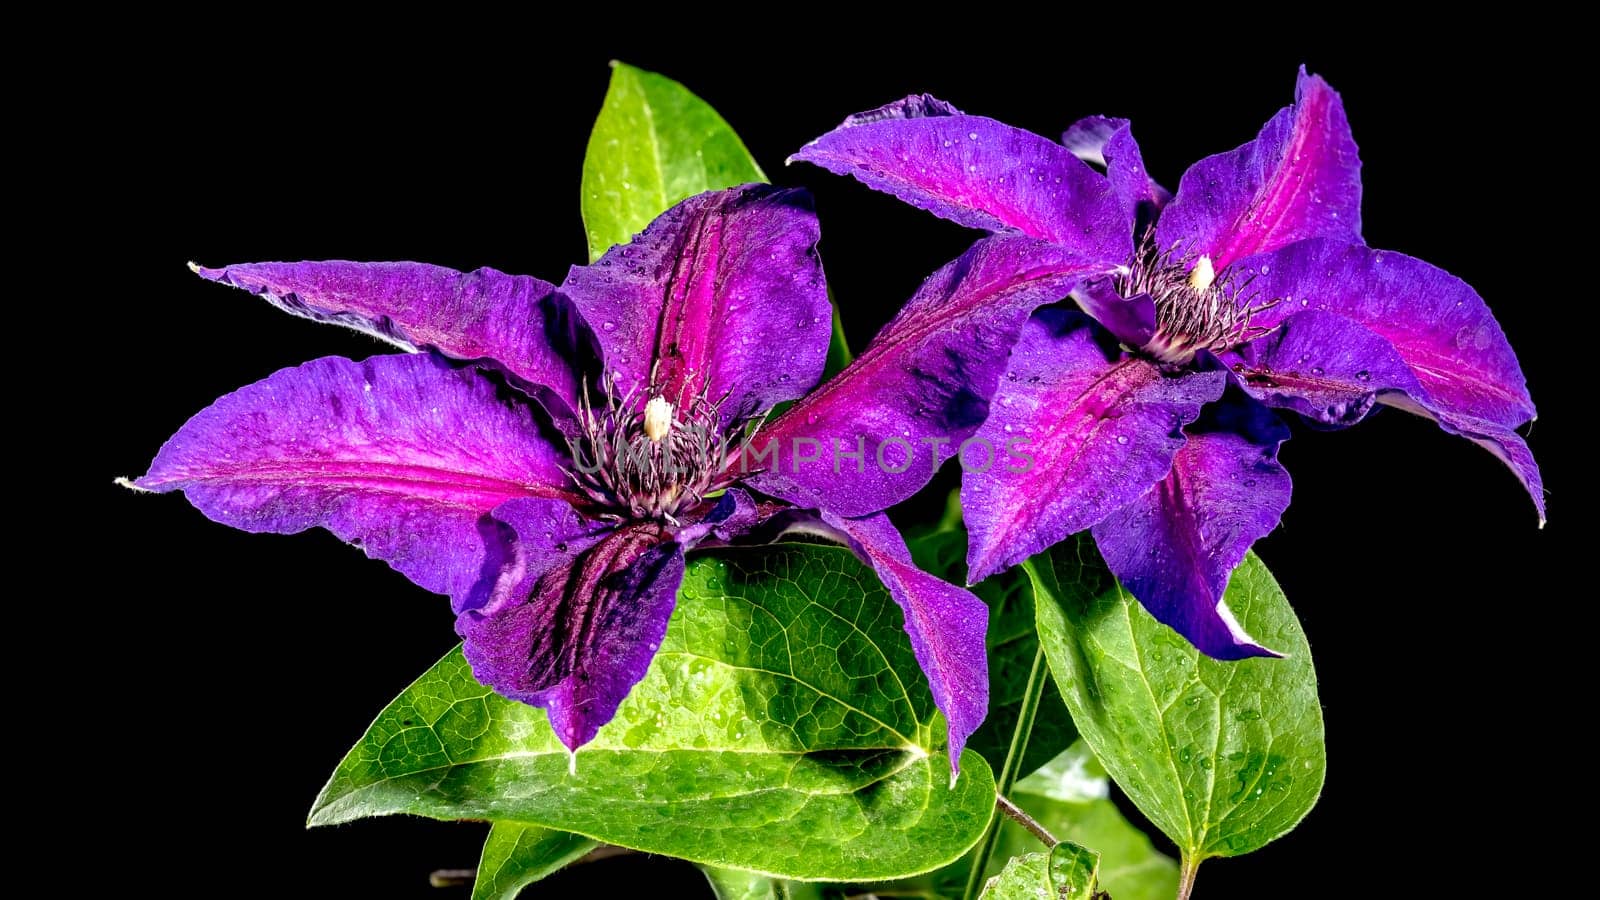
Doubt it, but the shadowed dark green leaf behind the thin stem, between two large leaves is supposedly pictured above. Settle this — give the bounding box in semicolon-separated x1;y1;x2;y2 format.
907;492;1078;775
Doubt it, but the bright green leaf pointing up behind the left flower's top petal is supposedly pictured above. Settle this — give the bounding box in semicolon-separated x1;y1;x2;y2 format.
582;62;766;263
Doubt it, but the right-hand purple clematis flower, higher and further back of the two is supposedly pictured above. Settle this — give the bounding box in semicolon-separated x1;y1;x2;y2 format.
794;69;1544;658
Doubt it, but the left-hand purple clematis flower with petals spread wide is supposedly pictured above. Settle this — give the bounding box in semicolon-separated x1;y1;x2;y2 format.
131;186;1113;765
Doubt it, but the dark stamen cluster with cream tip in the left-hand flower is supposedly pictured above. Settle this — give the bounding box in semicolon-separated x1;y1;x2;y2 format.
568;381;733;525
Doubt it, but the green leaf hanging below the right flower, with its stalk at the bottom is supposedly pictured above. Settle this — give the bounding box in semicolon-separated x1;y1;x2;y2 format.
1026;536;1326;866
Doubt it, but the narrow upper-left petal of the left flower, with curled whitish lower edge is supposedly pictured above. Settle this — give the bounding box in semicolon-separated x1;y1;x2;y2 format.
195;259;581;412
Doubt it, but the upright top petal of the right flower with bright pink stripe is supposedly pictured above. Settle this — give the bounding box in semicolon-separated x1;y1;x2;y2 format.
1155;67;1362;272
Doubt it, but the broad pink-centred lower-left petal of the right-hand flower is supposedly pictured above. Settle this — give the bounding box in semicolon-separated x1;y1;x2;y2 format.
962;307;1227;583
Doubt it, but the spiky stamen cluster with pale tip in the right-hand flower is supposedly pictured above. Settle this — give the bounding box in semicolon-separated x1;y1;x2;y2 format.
1117;235;1277;365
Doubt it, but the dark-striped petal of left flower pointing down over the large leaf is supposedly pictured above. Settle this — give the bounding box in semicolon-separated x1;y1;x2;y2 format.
456;522;683;751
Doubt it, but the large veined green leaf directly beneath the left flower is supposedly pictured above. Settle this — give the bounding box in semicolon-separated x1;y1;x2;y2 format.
310;544;994;881
